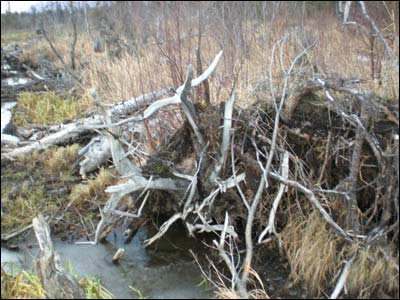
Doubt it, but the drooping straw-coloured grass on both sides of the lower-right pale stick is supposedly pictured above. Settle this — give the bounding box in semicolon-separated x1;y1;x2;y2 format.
282;212;399;298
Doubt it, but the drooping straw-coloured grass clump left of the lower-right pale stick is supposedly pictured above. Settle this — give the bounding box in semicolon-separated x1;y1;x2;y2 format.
282;212;340;294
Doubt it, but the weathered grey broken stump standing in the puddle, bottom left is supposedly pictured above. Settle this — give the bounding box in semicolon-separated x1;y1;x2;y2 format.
32;215;85;299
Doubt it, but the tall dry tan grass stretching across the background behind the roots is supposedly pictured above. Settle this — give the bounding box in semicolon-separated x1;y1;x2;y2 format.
14;15;399;111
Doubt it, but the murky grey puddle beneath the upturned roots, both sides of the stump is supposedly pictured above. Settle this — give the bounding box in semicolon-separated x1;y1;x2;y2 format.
1;221;214;299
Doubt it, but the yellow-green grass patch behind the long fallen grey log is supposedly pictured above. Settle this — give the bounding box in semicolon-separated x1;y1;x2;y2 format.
14;92;84;126
